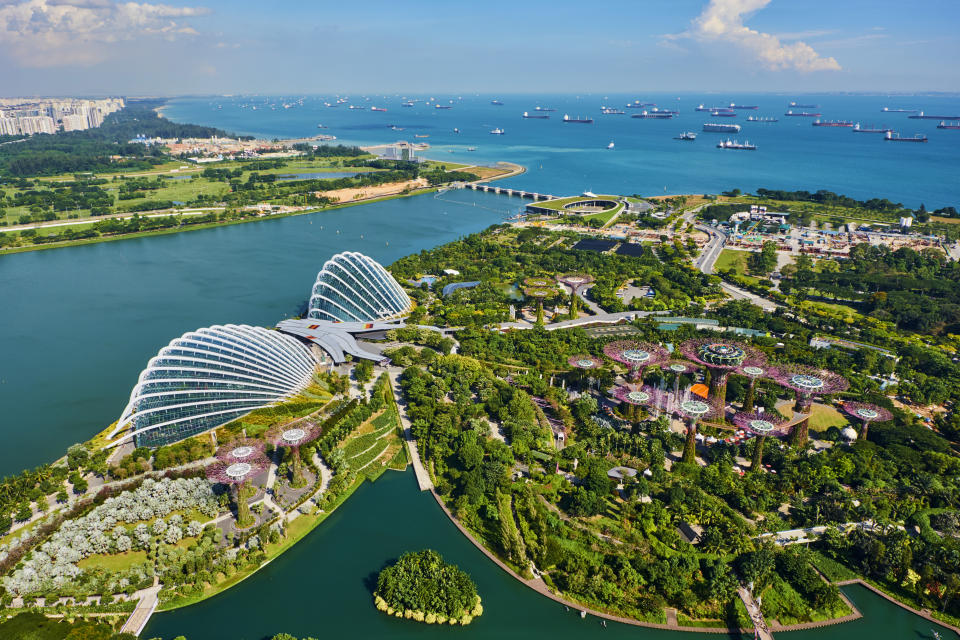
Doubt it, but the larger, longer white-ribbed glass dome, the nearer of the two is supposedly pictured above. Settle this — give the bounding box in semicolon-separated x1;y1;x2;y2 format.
109;324;317;446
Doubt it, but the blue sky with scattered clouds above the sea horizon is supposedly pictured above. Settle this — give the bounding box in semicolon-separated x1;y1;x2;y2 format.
0;0;960;96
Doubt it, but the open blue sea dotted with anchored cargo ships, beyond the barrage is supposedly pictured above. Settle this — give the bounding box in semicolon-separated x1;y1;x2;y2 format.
164;94;960;209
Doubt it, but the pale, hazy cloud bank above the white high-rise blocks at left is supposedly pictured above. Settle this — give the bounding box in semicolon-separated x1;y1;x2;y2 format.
0;0;209;67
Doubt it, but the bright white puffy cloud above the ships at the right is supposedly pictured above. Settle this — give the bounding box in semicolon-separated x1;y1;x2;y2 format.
672;0;840;72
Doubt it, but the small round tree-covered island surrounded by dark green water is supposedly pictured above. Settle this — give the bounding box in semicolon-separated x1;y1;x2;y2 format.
373;549;483;625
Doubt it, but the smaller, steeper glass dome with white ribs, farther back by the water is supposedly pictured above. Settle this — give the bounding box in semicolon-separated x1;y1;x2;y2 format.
307;251;413;322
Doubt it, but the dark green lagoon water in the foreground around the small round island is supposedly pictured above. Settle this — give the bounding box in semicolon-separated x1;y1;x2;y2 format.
142;470;951;640
